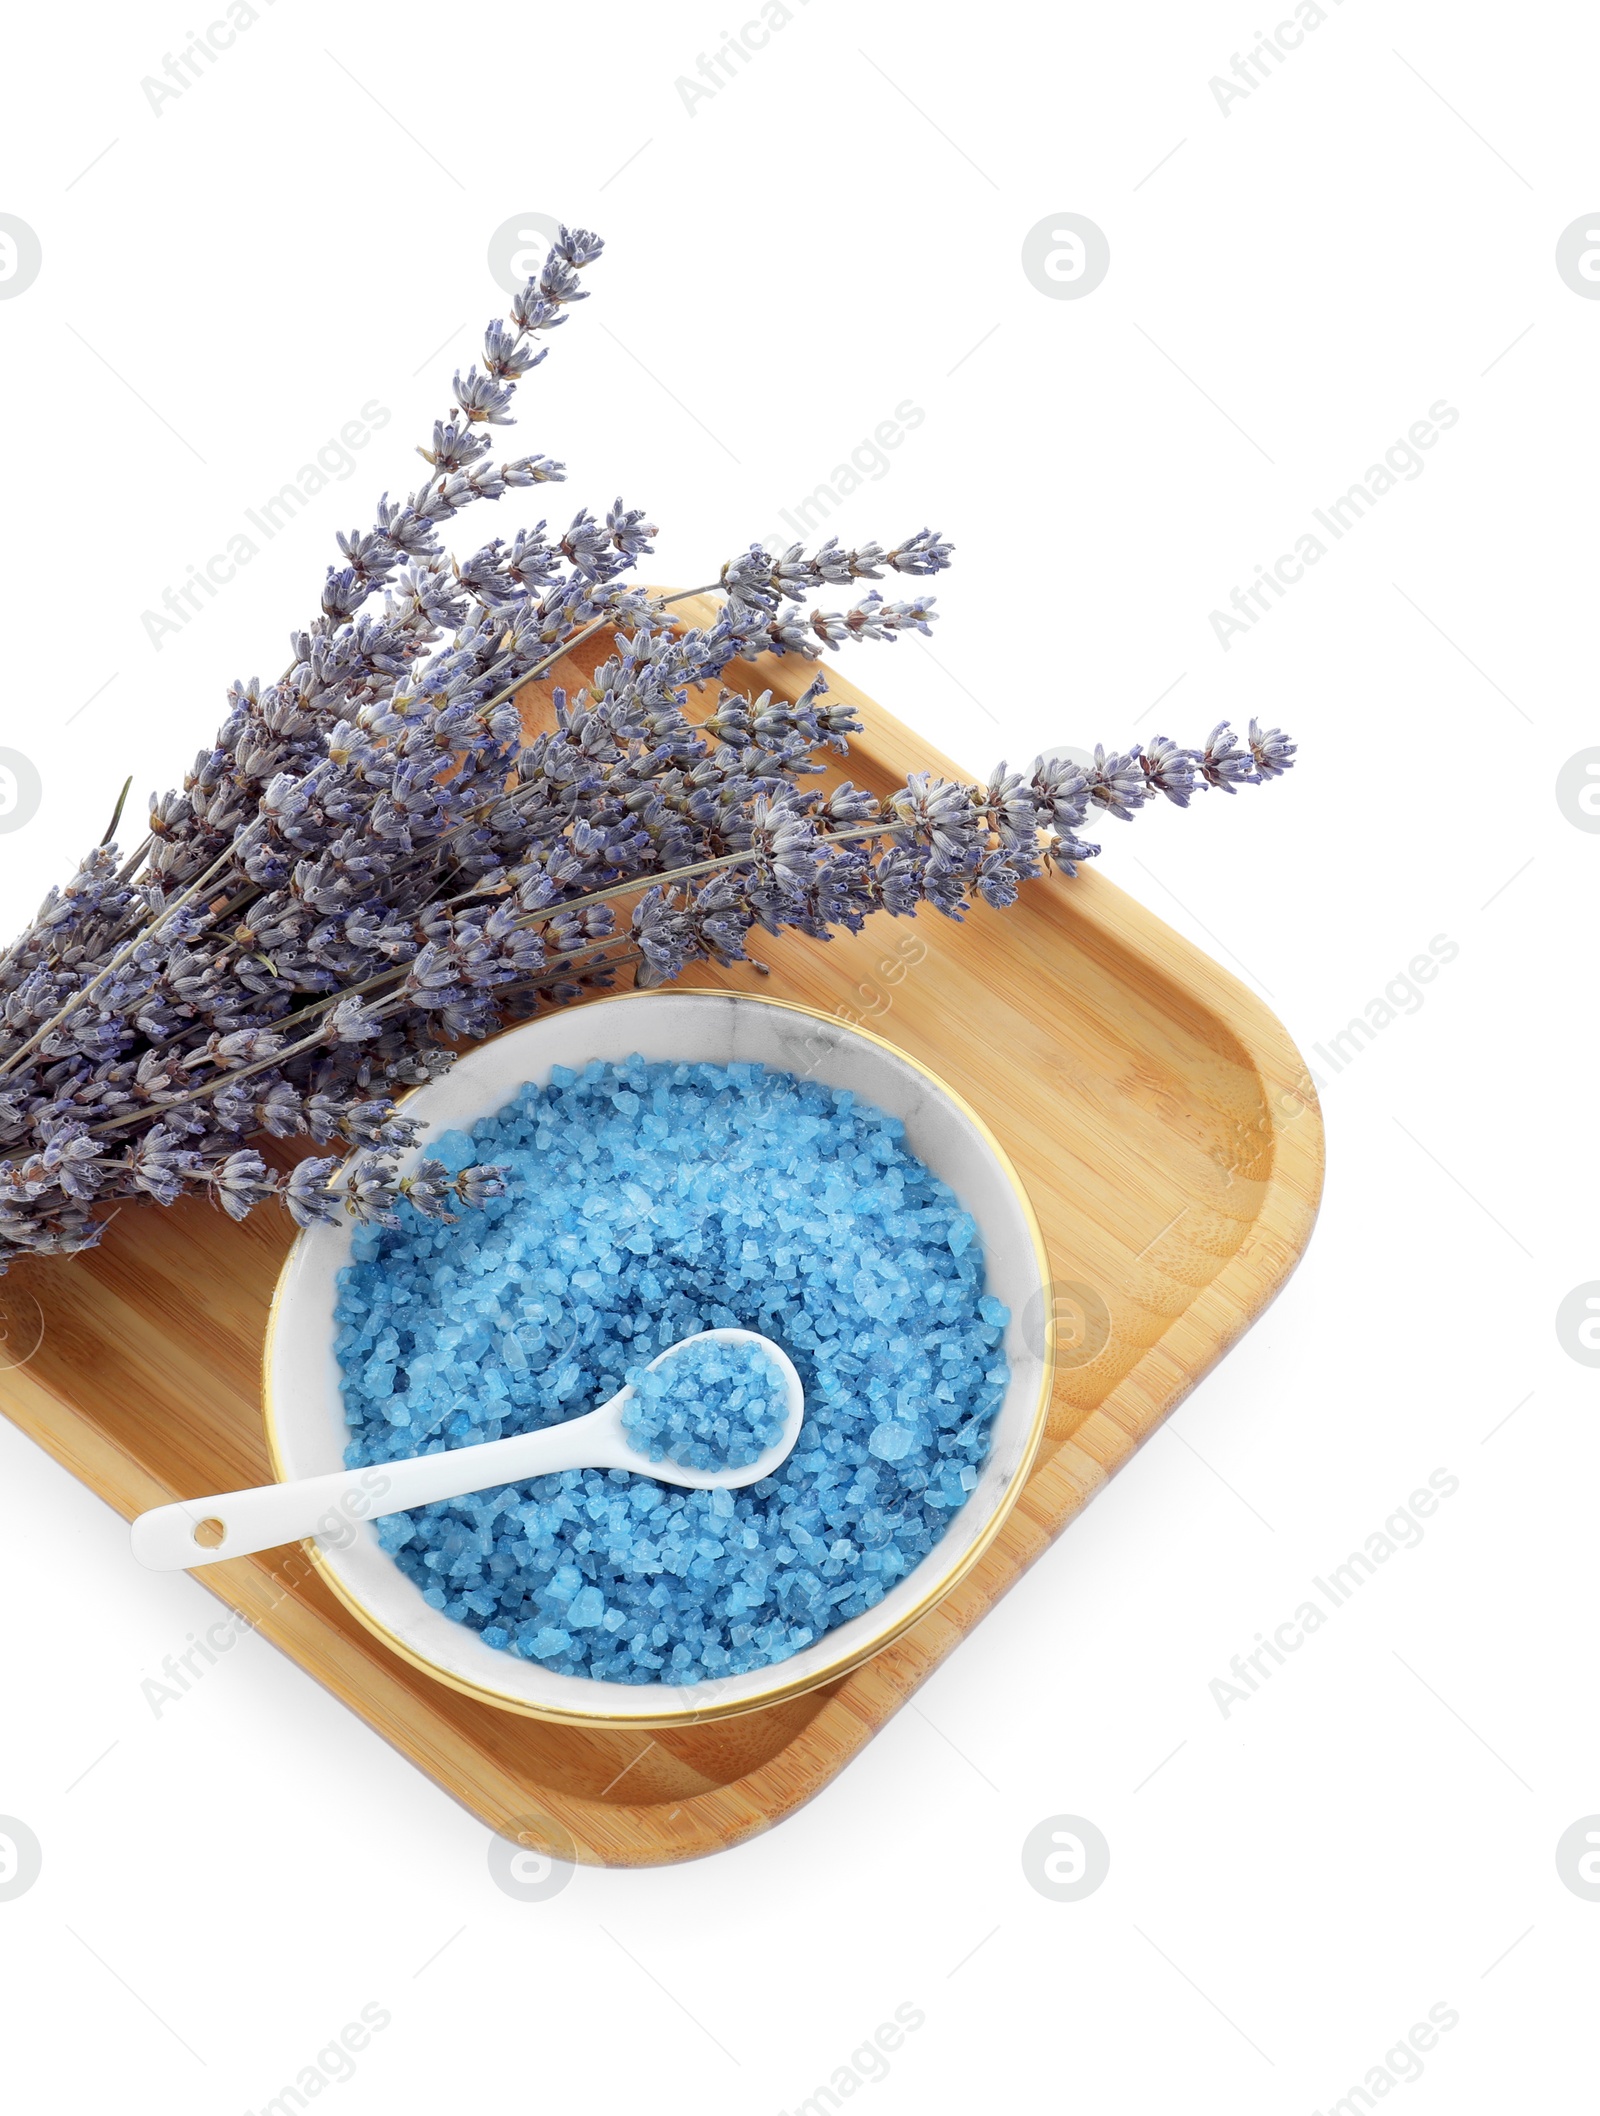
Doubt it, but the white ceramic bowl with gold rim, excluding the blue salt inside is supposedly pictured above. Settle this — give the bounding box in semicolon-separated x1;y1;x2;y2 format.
262;990;1052;1727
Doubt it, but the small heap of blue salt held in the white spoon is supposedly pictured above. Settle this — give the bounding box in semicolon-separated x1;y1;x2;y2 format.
622;1337;789;1469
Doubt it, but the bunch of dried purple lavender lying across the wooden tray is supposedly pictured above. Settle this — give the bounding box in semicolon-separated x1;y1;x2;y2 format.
0;229;1295;1270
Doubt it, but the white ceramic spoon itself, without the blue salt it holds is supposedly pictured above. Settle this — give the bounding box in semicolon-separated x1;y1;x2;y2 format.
131;1329;806;1572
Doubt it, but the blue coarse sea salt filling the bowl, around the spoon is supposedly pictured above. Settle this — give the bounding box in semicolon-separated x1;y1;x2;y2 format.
337;1056;1010;1684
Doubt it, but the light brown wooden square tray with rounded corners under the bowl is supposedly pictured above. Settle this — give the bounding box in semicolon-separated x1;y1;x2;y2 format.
0;605;1323;1866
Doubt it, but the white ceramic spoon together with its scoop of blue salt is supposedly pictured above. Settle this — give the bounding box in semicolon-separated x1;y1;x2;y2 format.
131;1329;806;1572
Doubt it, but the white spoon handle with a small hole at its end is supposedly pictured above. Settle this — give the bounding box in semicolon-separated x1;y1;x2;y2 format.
131;1390;631;1572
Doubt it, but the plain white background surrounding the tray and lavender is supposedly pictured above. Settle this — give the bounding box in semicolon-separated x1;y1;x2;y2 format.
0;0;1600;2116
